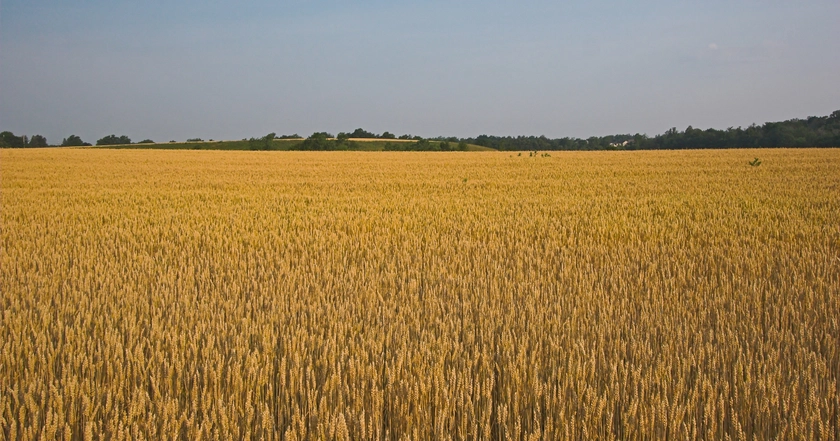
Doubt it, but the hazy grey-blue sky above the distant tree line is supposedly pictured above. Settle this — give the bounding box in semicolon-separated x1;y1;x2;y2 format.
0;0;840;143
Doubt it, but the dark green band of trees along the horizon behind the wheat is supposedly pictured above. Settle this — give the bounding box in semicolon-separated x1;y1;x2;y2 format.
0;110;840;151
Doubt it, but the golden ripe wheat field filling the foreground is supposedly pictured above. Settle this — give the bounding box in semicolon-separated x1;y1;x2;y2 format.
0;149;840;440
